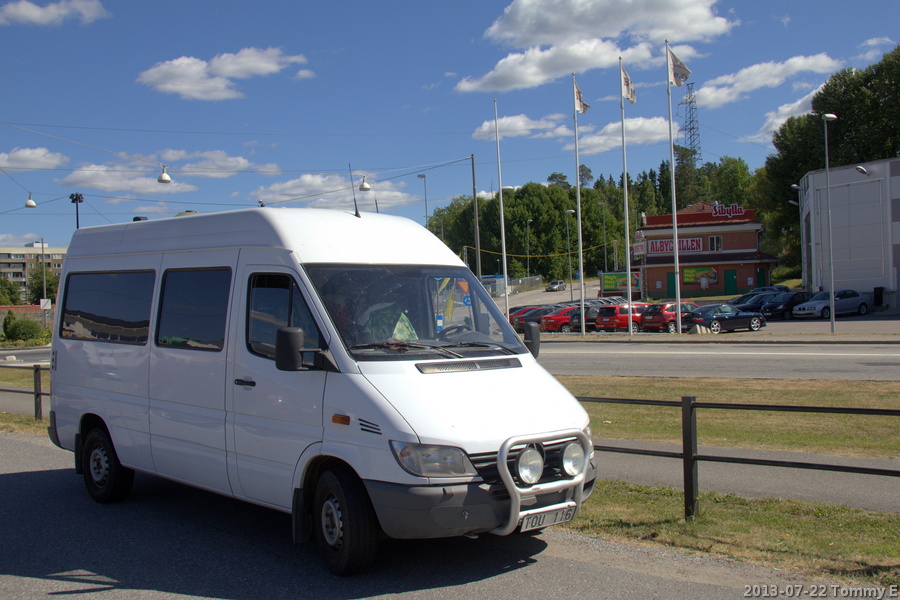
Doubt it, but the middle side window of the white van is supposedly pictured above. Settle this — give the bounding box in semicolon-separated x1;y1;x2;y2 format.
156;268;231;352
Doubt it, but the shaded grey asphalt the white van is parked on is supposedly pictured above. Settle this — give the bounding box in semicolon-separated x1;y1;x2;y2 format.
0;433;847;600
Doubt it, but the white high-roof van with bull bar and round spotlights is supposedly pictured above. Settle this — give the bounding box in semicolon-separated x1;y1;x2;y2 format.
49;208;595;574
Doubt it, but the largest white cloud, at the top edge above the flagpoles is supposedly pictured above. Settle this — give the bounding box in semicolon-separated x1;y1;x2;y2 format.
456;0;737;92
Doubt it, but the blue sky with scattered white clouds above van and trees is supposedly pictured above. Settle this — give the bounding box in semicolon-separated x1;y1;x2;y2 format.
0;0;900;246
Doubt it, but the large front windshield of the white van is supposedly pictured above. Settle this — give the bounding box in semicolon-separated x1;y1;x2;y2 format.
304;264;527;360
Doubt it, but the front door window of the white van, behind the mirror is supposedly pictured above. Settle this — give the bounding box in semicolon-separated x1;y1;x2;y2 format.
247;273;322;360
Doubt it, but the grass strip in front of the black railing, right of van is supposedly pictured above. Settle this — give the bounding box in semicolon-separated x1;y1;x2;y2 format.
561;481;900;587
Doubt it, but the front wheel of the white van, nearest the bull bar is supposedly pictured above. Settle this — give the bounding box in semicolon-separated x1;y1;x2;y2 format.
313;468;378;575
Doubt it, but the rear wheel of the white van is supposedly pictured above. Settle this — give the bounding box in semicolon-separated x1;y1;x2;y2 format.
81;427;134;504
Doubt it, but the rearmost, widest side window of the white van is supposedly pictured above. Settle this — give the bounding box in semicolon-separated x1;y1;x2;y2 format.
59;271;156;346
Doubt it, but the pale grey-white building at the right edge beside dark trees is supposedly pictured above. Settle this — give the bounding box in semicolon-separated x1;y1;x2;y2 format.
798;158;900;306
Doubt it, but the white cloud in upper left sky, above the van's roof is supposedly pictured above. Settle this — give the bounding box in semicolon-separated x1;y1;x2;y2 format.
138;48;315;101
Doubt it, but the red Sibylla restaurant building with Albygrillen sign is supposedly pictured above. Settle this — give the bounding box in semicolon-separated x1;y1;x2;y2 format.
635;202;778;298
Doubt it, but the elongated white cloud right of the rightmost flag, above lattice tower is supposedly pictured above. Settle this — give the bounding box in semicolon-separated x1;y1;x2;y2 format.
697;53;841;108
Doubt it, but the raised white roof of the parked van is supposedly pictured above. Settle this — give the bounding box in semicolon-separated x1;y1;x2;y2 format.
67;207;463;265
